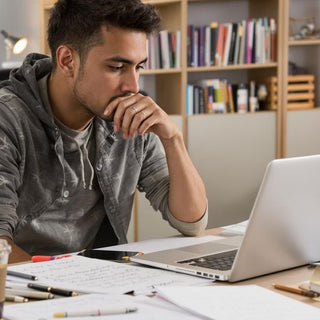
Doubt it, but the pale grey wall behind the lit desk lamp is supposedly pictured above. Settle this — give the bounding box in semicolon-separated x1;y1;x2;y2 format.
0;0;41;64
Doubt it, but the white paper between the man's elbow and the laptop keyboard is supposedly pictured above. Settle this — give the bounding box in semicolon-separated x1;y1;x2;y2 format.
101;236;222;253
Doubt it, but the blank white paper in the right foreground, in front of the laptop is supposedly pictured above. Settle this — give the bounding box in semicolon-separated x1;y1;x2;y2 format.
156;285;320;320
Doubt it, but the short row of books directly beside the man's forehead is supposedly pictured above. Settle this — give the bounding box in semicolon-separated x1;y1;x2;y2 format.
146;30;181;69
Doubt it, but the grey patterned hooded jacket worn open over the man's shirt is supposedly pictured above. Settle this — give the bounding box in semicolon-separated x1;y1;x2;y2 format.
0;54;207;254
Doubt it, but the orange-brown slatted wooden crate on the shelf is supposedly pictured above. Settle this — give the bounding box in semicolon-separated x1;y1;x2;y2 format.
267;74;314;110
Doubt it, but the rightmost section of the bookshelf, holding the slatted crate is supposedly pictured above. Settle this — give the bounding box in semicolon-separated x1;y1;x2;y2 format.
283;0;320;157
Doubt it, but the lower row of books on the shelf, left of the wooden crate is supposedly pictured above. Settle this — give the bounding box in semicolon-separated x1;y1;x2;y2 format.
186;79;268;115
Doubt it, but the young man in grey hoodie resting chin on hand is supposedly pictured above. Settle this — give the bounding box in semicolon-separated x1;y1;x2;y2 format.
0;0;207;261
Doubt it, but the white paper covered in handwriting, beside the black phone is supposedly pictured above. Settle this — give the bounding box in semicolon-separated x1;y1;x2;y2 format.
8;256;212;294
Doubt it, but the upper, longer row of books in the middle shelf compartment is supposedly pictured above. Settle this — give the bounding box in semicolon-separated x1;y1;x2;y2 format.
187;17;277;67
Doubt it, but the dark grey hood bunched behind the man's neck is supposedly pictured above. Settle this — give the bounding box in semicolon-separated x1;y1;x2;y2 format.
0;53;52;126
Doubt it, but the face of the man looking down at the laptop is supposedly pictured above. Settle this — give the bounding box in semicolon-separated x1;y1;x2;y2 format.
73;27;147;116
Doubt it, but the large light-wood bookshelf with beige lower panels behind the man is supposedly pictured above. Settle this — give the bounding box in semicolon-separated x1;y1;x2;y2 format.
41;0;320;240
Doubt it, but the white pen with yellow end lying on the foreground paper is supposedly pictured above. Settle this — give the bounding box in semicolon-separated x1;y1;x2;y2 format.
53;307;138;318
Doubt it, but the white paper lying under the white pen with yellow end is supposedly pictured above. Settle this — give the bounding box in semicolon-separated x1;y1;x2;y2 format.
4;294;199;320
